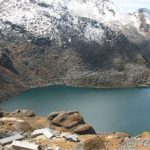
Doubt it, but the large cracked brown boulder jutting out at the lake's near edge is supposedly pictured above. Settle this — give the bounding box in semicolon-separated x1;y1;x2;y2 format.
48;111;96;134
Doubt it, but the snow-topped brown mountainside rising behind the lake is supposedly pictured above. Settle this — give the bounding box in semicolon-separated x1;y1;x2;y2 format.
0;0;150;100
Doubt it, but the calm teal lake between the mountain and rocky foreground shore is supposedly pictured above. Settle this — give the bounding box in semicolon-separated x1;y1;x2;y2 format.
0;86;150;135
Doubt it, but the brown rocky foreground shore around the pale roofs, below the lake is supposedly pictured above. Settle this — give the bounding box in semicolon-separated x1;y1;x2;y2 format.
0;109;150;150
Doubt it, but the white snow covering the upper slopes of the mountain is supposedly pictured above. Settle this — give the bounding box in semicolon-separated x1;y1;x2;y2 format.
0;0;150;43
